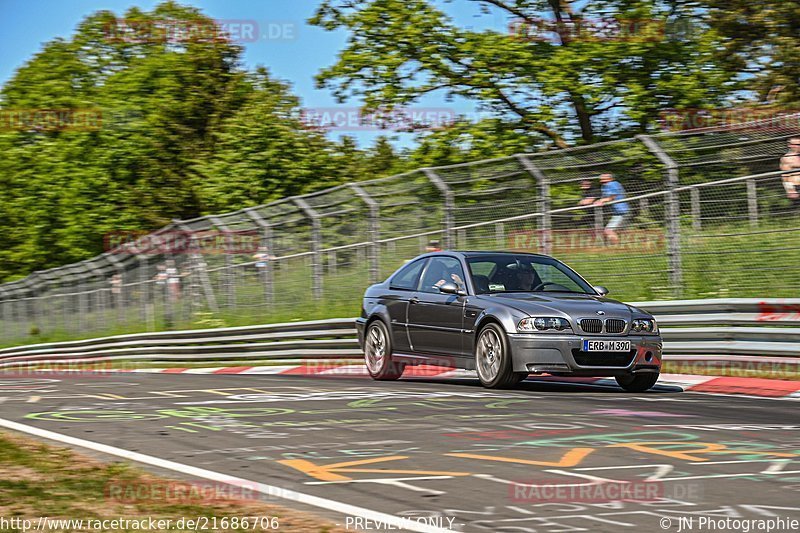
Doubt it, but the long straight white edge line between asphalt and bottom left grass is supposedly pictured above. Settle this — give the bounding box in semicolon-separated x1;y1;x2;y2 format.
0;418;452;533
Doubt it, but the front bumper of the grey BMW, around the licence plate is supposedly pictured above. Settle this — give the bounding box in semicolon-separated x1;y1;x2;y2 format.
508;333;662;376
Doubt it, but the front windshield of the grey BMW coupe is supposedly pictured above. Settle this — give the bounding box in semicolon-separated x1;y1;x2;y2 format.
467;254;596;294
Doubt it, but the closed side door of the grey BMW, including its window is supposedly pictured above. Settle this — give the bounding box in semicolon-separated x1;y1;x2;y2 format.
408;256;465;356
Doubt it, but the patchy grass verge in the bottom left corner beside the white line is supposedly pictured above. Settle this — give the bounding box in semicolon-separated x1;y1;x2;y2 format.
0;432;344;533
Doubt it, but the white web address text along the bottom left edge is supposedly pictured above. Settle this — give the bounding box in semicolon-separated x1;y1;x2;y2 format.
0;515;280;533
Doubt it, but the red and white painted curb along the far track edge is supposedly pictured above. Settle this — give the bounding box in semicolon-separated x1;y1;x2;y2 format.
20;363;800;400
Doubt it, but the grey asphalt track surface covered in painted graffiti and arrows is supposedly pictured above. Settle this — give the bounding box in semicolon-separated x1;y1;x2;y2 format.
0;374;800;532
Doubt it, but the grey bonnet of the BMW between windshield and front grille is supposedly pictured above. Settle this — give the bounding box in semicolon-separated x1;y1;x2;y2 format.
481;292;649;320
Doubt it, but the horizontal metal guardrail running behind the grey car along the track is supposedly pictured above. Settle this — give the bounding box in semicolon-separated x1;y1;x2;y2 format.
0;298;800;367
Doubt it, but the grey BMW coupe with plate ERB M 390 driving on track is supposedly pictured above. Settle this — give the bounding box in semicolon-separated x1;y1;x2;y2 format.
356;251;661;392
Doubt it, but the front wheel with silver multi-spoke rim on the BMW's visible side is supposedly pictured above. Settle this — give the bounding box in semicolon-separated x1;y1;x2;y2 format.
475;323;528;389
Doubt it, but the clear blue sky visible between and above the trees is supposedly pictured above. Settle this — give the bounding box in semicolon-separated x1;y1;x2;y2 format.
0;0;506;146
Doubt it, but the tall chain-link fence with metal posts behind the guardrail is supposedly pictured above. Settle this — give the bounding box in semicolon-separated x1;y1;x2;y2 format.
0;115;800;344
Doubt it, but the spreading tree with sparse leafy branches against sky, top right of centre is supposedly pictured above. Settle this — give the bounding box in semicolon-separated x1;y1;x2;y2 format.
311;0;732;146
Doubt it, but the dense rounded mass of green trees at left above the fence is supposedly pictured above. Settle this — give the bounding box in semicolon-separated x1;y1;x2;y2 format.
0;2;374;280
